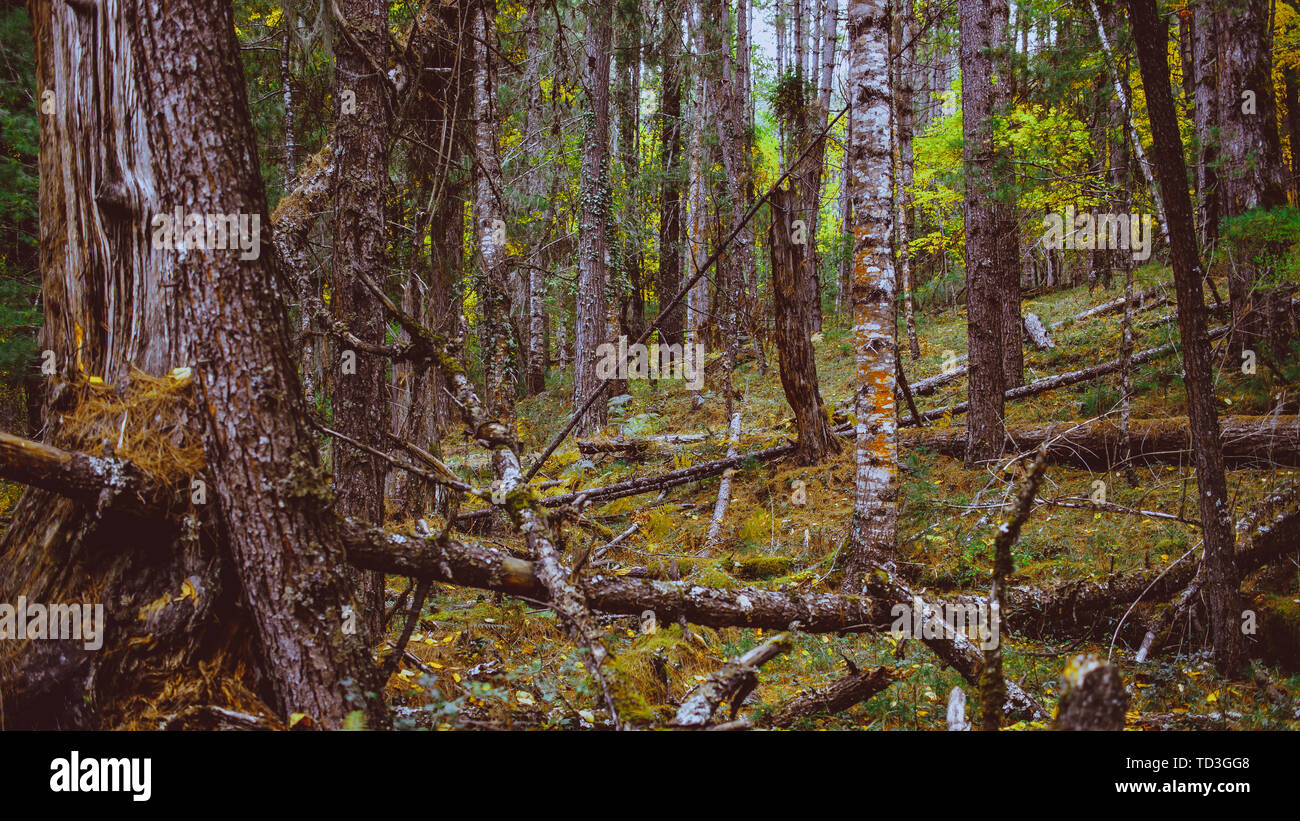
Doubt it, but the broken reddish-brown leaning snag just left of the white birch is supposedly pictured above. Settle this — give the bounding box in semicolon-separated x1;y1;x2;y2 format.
768;187;837;465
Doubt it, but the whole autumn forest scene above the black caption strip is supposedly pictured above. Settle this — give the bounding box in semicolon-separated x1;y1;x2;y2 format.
0;0;1300;730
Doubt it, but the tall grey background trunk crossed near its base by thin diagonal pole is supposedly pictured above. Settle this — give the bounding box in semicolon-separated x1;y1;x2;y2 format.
573;0;611;433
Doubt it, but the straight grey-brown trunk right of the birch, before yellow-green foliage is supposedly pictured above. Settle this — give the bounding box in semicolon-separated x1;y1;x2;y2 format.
958;0;1019;465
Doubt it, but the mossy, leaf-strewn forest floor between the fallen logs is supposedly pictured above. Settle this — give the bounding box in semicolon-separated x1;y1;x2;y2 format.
366;268;1300;729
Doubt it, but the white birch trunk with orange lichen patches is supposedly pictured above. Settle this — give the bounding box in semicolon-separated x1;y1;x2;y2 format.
837;0;898;594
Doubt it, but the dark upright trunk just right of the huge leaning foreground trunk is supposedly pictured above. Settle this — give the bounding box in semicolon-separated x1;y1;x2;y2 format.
329;0;391;639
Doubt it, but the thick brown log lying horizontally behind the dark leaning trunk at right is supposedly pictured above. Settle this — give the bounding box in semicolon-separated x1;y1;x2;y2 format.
900;416;1300;470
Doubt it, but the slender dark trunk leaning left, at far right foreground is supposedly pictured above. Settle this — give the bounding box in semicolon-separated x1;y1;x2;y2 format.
1126;0;1243;674
